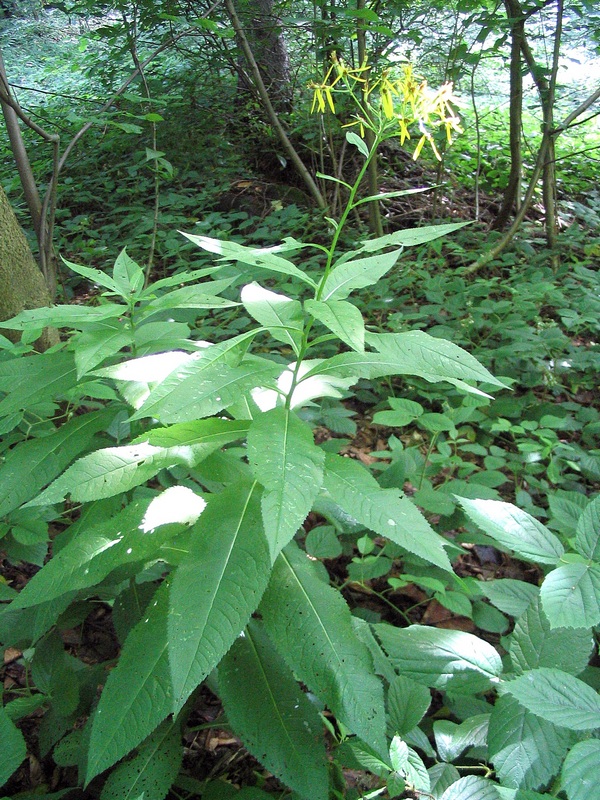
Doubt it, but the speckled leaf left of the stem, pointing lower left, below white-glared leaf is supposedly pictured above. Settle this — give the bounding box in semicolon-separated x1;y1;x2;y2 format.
132;340;281;422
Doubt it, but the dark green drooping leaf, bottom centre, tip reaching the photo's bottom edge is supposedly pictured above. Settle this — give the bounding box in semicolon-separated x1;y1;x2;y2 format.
219;620;329;800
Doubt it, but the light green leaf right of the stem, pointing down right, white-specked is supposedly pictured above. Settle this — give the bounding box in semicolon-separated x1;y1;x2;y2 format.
323;454;452;571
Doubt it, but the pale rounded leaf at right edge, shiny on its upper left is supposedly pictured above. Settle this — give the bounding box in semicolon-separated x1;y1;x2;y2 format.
540;562;600;628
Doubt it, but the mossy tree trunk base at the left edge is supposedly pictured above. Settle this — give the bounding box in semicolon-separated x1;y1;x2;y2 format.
0;186;58;350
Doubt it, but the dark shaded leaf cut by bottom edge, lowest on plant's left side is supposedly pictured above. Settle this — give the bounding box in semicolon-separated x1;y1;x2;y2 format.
100;722;183;800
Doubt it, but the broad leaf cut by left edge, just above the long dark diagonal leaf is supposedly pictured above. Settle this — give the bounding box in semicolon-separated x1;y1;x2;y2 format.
0;352;77;417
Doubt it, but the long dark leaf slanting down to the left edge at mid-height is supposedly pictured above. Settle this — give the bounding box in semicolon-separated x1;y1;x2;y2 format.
0;410;115;517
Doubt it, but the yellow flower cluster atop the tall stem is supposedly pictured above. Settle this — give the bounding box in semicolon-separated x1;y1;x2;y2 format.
309;53;462;160
